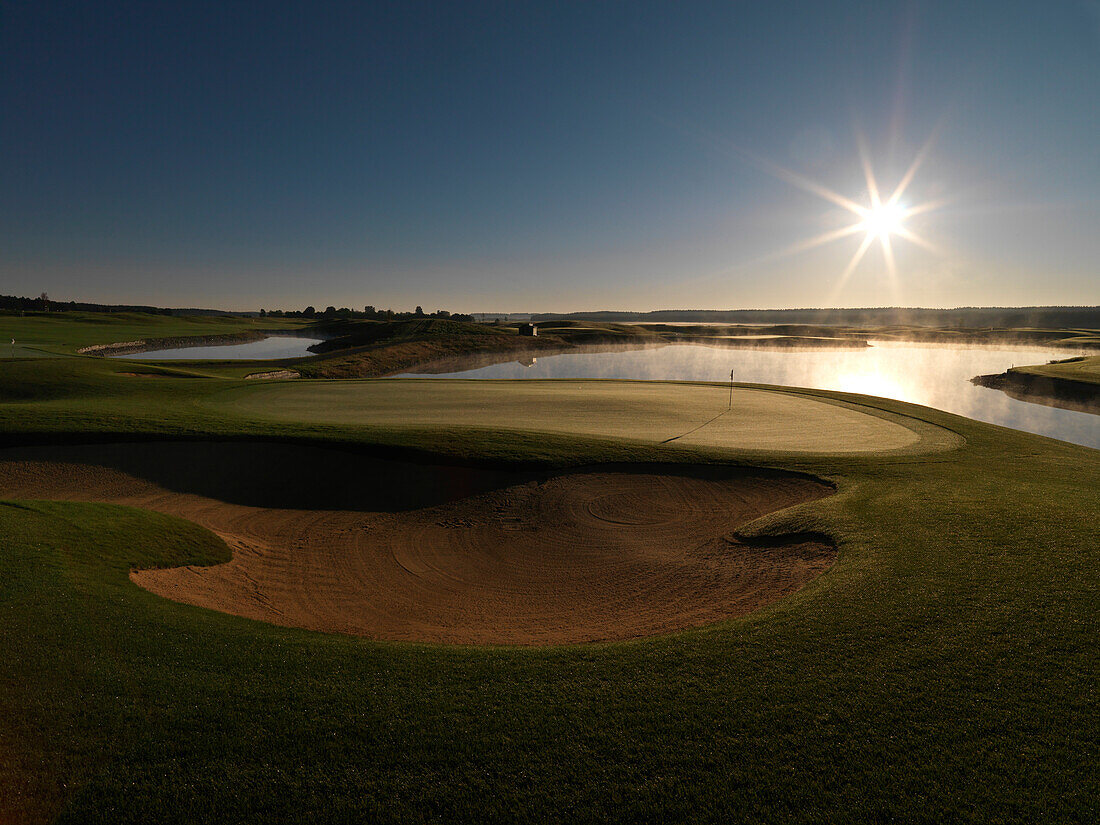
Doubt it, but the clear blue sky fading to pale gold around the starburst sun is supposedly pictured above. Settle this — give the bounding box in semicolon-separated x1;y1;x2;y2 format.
0;0;1100;311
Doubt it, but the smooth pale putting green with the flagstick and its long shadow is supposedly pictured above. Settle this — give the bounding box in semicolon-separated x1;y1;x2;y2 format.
208;380;958;453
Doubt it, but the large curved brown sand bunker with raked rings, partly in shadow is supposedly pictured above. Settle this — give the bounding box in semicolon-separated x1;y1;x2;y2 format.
0;443;836;645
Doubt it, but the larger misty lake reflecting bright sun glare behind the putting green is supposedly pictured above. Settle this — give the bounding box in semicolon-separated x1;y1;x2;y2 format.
406;341;1100;448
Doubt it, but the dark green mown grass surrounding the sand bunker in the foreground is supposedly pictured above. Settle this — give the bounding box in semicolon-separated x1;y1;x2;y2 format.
0;336;1100;823
